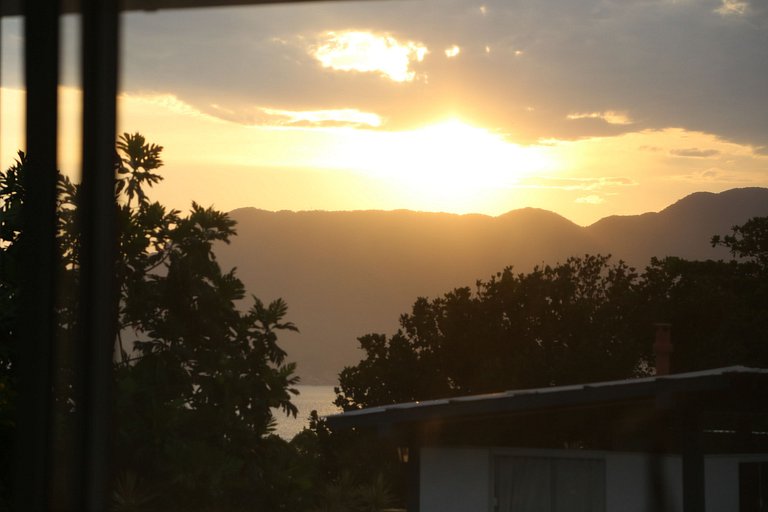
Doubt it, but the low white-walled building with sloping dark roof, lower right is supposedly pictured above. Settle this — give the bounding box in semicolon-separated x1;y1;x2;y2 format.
328;366;768;512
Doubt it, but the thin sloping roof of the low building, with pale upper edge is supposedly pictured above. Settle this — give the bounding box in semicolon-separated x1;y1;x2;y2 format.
326;366;768;427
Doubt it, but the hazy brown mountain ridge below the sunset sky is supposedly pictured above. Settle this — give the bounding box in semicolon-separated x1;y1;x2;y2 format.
217;188;768;384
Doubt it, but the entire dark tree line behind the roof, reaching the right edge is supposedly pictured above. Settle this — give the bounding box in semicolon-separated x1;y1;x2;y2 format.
336;222;768;410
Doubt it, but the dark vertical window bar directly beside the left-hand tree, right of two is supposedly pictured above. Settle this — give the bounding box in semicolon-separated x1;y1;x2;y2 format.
78;0;118;511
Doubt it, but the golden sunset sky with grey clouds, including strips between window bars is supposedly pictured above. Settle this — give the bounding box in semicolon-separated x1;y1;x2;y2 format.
0;0;768;225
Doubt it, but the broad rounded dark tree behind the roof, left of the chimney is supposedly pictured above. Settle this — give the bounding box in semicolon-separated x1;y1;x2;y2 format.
337;256;650;409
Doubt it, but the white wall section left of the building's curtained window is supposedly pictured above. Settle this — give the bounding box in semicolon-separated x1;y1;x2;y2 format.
419;447;493;512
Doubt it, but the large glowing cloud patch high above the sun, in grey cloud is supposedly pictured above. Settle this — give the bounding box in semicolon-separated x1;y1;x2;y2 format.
310;30;429;82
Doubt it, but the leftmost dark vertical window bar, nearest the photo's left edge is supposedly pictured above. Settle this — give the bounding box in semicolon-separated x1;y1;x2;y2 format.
16;0;59;510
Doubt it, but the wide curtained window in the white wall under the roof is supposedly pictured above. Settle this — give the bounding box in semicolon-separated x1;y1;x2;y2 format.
495;456;605;512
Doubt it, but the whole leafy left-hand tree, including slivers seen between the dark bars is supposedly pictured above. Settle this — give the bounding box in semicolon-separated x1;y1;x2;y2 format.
0;134;302;510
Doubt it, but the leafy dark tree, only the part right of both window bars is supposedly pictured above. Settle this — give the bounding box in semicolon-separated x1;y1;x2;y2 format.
116;135;308;510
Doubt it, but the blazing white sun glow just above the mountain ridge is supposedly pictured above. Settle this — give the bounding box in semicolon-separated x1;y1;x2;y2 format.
318;118;555;212
